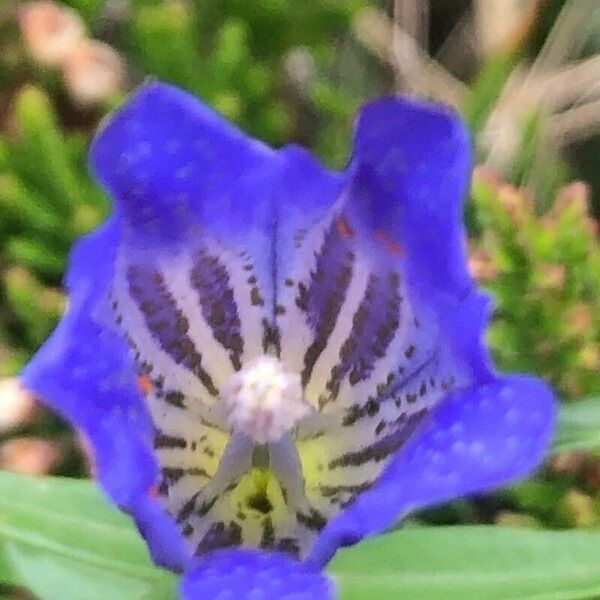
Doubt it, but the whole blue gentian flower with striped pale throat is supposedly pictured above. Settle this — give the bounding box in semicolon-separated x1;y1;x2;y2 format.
23;83;554;598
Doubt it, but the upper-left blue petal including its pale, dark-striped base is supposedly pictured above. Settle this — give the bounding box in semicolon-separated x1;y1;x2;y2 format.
90;83;284;384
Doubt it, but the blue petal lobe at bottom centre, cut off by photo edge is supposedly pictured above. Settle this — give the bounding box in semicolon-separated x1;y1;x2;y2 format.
180;550;334;600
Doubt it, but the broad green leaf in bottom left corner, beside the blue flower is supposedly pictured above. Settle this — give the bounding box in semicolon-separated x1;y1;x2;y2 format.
0;472;176;600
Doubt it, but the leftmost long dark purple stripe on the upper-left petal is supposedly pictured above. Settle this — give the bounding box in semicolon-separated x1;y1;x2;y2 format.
127;265;219;396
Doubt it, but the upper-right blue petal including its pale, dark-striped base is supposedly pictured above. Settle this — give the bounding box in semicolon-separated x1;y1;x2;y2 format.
276;98;491;424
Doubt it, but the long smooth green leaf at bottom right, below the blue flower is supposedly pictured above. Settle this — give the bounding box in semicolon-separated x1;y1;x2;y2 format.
328;526;600;600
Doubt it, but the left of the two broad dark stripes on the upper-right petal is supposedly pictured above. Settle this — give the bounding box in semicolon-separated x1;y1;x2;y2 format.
296;218;355;386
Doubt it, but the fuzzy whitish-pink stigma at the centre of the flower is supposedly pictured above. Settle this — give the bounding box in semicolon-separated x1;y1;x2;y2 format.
221;356;309;444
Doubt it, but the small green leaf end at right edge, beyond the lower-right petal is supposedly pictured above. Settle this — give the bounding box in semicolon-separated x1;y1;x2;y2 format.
552;397;600;452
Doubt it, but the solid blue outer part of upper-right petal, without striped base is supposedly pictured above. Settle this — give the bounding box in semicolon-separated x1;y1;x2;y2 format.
348;98;492;380
